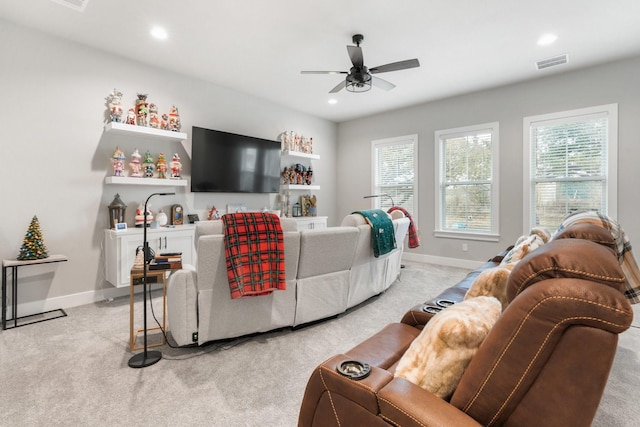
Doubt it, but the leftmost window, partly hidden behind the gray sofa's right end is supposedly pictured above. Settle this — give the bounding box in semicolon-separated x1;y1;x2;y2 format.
371;135;418;221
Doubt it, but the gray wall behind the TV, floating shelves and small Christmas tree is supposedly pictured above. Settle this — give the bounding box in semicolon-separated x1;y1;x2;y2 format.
0;20;337;315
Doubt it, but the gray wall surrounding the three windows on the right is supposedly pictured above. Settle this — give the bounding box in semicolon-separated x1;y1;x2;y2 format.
337;57;640;261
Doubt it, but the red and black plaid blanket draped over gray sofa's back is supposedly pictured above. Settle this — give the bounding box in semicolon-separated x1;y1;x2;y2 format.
222;212;286;299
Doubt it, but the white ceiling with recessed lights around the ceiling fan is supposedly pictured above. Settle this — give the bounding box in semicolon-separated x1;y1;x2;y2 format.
0;0;640;122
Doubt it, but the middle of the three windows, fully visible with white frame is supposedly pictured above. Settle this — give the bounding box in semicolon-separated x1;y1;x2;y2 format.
435;122;499;241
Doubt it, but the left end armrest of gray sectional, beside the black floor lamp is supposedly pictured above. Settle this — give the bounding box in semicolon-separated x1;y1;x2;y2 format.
167;265;198;346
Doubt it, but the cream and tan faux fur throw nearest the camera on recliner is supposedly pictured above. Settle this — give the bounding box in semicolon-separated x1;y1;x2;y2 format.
395;296;502;399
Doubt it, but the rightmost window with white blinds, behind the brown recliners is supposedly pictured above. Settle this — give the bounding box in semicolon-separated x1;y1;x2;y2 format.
523;104;618;231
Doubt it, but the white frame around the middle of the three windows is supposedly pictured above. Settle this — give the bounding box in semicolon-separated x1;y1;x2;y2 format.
434;122;500;242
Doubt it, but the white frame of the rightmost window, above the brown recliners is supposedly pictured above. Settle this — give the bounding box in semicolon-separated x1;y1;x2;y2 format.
522;104;618;233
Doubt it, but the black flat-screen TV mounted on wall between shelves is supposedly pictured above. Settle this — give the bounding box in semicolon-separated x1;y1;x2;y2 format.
191;126;280;193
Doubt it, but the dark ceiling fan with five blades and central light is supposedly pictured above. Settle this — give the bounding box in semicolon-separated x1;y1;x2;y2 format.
300;34;420;93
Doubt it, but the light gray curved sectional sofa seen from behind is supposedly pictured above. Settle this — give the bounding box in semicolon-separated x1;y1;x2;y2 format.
167;212;410;346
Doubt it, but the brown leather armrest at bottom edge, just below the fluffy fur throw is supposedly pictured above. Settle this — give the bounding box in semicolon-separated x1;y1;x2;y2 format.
378;378;481;427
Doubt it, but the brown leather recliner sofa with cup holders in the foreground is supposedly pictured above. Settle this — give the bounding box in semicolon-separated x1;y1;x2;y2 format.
298;225;633;427
